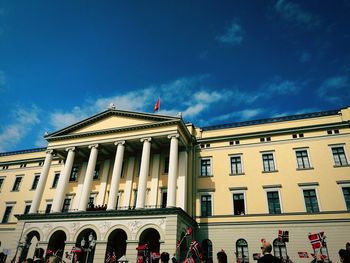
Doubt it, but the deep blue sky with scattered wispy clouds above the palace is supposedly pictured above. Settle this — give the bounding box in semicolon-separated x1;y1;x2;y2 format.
0;0;350;152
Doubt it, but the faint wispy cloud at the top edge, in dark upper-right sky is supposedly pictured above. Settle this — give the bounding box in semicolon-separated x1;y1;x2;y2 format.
275;0;321;29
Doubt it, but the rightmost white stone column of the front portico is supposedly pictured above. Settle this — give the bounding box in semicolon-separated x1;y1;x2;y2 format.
166;134;179;207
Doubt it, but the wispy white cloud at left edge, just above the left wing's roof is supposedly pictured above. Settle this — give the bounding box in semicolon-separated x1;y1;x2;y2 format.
0;106;40;152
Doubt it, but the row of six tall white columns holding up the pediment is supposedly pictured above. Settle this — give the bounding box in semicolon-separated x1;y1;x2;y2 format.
29;134;179;213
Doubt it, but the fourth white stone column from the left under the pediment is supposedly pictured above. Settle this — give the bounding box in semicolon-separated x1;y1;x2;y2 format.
107;141;125;210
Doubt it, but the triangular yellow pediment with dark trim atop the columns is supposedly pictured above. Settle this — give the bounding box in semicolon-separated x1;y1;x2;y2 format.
46;109;181;139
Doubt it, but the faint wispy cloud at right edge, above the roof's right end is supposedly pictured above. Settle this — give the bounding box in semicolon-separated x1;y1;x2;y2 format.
317;75;350;104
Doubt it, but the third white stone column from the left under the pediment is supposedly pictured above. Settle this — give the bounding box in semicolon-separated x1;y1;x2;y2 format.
78;144;98;211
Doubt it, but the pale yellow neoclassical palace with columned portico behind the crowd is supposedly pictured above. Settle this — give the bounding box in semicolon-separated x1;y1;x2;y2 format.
0;107;350;262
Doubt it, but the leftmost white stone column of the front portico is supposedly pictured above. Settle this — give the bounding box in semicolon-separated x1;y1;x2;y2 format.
29;150;53;214
